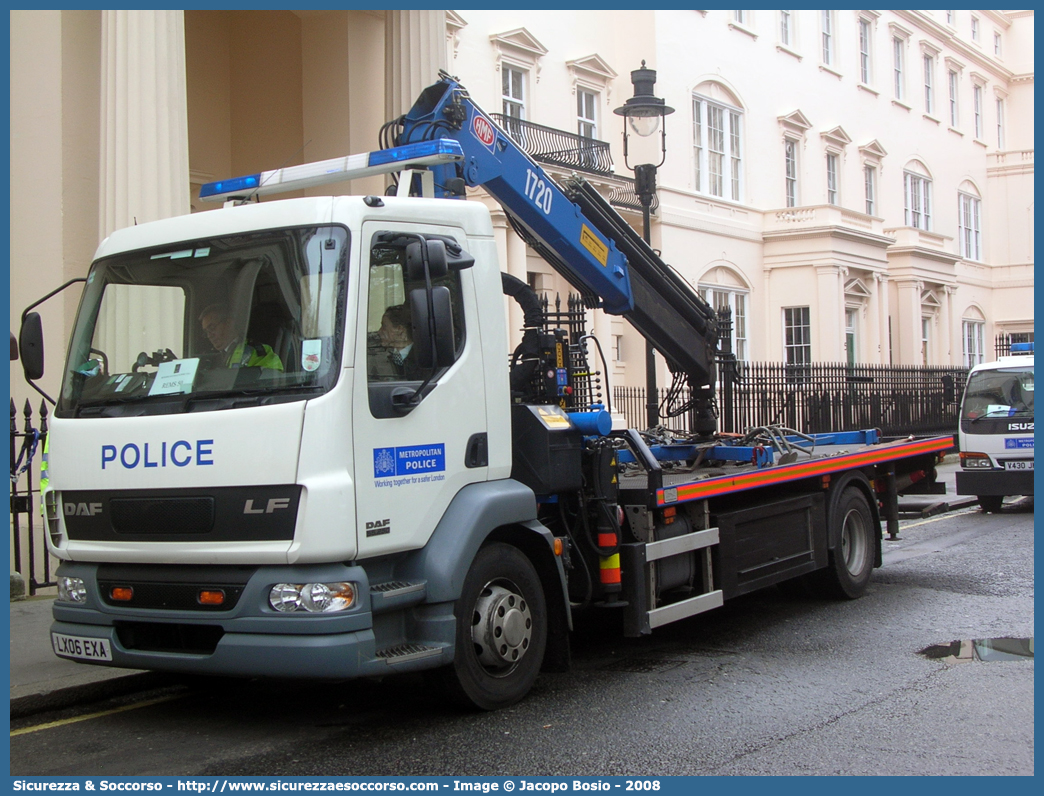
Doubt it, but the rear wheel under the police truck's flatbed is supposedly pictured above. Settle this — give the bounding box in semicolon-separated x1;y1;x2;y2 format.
811;487;878;600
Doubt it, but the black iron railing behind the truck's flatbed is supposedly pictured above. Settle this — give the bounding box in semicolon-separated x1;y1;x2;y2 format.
613;362;968;437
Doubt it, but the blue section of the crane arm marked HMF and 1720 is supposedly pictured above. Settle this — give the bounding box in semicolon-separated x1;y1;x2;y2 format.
399;77;634;315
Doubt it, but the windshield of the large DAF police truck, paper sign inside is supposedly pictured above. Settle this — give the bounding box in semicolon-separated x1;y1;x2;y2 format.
57;226;349;417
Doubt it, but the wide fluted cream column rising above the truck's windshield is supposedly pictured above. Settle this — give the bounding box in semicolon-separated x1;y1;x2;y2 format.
99;10;189;237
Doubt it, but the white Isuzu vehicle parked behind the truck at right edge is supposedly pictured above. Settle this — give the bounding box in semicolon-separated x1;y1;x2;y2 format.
957;343;1034;512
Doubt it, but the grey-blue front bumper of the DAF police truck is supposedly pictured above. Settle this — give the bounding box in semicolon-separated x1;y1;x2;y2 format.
51;563;394;679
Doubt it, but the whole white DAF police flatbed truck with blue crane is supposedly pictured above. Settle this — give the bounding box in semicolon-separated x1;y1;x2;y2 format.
22;74;952;709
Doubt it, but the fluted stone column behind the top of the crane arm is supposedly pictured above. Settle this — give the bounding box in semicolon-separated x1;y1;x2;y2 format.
384;9;447;119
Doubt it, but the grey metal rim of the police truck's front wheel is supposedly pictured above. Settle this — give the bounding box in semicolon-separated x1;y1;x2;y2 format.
471;580;532;677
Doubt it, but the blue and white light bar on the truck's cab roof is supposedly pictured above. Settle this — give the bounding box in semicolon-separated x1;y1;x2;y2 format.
199;138;464;202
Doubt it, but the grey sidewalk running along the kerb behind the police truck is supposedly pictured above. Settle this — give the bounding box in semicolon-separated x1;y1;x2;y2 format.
10;455;974;716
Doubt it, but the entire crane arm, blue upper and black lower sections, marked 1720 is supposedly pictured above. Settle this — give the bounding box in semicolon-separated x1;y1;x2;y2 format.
397;73;718;415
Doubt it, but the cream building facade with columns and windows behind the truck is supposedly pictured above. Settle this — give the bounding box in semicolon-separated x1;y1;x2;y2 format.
10;10;1034;409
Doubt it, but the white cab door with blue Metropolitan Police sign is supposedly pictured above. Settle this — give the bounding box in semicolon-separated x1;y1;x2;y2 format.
353;221;489;558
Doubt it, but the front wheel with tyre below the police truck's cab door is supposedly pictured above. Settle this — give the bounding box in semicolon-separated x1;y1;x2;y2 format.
442;542;547;710
